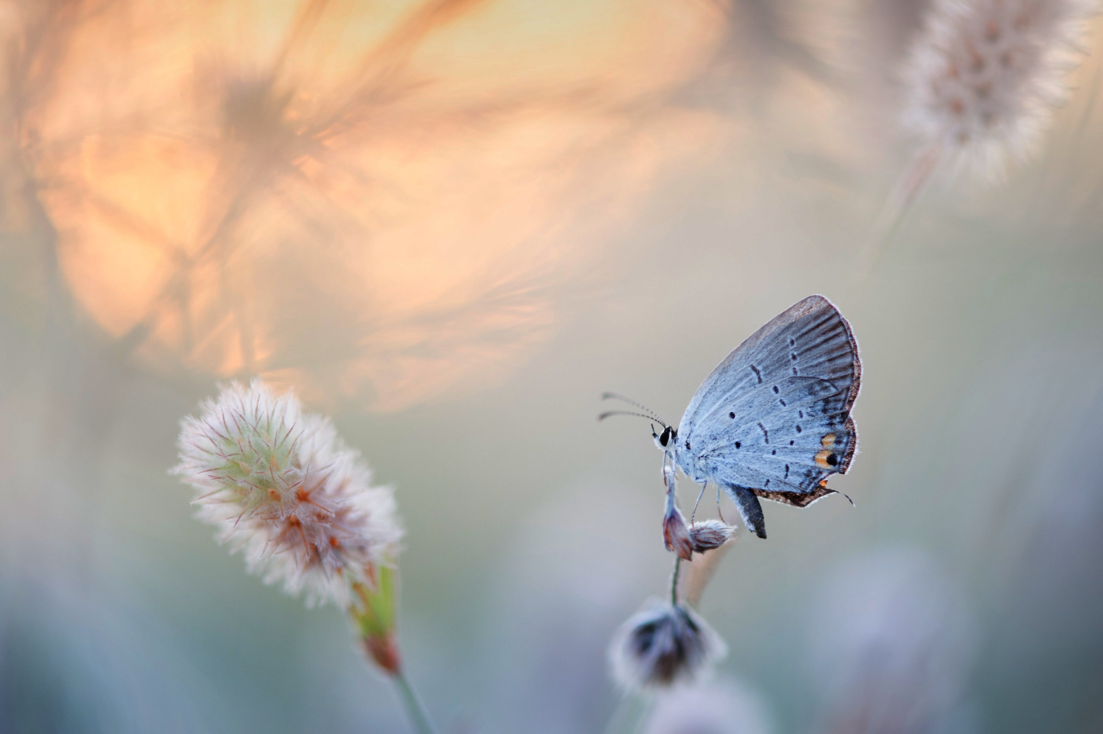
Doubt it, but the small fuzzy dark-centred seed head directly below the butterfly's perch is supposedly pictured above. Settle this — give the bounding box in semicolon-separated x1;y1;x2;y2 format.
609;602;728;691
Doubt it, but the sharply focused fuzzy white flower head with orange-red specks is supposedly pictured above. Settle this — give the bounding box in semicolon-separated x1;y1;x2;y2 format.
172;380;403;606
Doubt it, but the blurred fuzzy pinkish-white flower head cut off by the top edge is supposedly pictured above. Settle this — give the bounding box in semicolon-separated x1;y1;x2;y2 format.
902;0;1095;177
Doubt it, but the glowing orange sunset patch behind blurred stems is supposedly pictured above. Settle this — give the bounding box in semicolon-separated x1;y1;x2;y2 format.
22;0;721;409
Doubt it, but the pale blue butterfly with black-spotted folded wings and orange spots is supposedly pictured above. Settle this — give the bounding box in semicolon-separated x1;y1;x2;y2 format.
599;296;861;543
